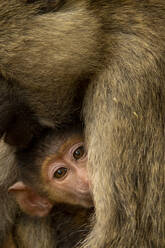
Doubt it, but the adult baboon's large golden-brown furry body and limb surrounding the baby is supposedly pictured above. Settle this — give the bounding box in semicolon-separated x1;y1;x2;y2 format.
0;0;165;248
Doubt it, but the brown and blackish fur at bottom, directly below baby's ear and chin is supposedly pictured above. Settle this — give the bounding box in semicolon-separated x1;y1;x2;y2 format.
12;205;92;248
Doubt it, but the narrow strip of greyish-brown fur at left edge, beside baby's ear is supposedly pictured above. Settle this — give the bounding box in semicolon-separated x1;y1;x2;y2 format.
0;140;18;247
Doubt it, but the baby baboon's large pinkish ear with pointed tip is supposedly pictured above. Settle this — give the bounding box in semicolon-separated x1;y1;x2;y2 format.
8;181;52;217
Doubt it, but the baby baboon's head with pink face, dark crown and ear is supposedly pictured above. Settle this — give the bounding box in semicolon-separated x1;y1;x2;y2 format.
9;129;93;216
